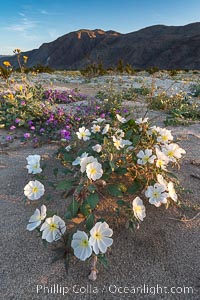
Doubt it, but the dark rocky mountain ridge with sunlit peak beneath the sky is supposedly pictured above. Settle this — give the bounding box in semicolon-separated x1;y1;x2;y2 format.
0;22;200;69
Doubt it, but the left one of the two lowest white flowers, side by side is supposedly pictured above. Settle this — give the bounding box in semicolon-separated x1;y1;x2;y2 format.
71;230;92;261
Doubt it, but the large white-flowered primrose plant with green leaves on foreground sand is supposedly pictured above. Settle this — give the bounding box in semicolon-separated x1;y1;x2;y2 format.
24;114;185;280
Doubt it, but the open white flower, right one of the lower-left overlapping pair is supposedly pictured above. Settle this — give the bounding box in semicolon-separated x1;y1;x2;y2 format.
40;215;66;243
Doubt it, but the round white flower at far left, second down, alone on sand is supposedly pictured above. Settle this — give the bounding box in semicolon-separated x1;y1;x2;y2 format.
24;180;45;200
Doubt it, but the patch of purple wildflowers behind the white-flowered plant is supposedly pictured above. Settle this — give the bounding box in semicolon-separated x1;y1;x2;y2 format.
6;90;128;143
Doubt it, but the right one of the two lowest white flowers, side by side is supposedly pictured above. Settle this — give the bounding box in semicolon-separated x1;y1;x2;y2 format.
89;222;113;255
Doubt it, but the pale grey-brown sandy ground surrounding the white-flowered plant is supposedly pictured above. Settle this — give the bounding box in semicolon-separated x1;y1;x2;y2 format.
0;75;200;300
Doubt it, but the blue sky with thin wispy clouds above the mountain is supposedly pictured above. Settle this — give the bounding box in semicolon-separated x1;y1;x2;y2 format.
0;0;200;54
